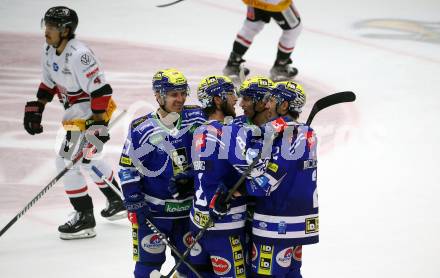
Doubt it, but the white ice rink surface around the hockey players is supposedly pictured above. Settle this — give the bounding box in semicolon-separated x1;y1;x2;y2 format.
0;0;440;278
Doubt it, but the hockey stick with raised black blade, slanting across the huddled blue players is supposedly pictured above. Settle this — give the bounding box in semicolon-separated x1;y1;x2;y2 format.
165;91;356;278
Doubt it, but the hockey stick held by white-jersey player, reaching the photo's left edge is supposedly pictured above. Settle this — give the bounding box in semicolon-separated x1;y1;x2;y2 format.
0;110;127;236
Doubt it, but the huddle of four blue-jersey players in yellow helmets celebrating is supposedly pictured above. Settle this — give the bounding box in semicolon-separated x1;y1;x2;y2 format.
119;69;319;277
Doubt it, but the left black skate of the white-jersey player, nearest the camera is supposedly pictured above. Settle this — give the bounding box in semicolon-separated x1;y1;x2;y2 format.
58;210;96;240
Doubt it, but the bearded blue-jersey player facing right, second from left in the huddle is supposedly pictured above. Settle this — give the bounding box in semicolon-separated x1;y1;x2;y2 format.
186;76;253;278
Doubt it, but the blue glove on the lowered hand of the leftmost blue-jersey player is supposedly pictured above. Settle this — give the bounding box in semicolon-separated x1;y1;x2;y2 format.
124;193;151;224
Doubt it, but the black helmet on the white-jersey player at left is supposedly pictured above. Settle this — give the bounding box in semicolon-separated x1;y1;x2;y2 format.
41;6;78;38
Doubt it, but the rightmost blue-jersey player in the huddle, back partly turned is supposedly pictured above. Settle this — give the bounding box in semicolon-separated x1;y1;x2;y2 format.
246;82;319;278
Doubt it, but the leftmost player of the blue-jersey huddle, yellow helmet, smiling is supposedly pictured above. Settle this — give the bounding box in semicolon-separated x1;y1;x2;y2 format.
119;69;205;278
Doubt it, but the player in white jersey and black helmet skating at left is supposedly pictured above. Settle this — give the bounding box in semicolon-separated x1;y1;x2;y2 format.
23;6;125;239
